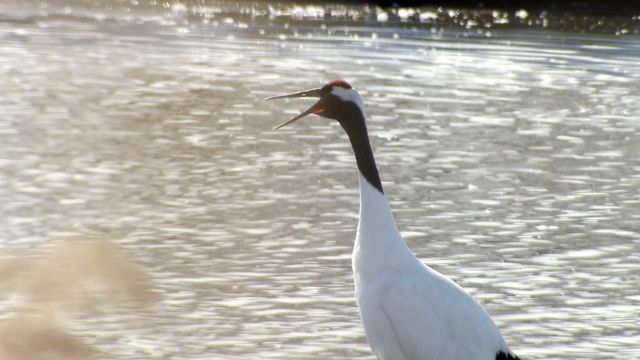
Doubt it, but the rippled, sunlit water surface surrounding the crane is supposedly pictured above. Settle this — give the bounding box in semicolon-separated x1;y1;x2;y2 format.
0;3;640;359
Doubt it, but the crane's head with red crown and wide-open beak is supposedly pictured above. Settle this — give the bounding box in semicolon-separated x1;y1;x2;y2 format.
266;80;364;130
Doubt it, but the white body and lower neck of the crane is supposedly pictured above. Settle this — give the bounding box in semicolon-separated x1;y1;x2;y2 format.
353;174;509;360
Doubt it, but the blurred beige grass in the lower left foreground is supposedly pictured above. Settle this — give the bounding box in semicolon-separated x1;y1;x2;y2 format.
0;237;157;360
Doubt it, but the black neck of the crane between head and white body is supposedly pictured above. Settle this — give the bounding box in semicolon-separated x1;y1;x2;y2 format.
338;104;384;194
